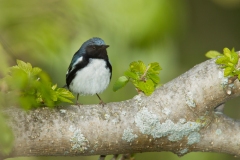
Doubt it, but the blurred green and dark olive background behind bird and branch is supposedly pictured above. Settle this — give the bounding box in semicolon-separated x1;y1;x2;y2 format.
0;0;240;160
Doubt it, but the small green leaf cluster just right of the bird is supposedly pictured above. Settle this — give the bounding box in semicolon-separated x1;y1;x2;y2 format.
113;61;162;95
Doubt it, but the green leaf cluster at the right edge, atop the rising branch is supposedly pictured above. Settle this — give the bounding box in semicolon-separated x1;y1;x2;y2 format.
206;48;240;80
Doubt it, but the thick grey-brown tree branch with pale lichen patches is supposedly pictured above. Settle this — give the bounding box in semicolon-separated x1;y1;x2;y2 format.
3;60;240;157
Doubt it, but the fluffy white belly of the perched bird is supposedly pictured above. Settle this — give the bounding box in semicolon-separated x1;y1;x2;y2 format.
69;59;111;95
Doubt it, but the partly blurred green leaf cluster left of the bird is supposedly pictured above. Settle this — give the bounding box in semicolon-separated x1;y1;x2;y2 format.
1;60;74;109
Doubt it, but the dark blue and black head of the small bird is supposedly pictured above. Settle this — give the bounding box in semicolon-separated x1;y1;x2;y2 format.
79;37;109;59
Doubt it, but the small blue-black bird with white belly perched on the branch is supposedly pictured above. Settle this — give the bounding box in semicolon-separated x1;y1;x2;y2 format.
66;37;112;105
